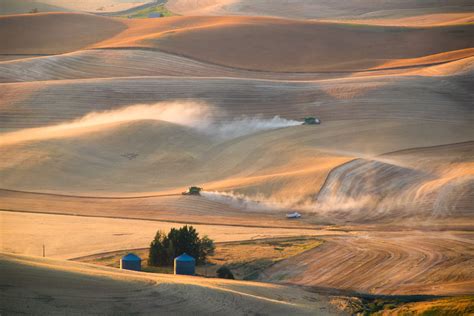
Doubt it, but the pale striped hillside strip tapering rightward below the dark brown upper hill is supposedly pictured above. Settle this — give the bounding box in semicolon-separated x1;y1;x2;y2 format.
0;49;346;83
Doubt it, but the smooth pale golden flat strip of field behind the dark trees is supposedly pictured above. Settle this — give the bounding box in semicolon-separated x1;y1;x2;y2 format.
0;211;334;259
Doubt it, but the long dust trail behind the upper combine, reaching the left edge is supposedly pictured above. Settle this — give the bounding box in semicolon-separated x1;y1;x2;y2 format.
0;101;301;145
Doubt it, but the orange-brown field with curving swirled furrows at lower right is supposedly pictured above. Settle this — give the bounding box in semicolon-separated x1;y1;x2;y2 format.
261;231;474;295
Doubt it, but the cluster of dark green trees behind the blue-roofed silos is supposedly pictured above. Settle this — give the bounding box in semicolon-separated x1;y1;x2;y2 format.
148;225;215;267
